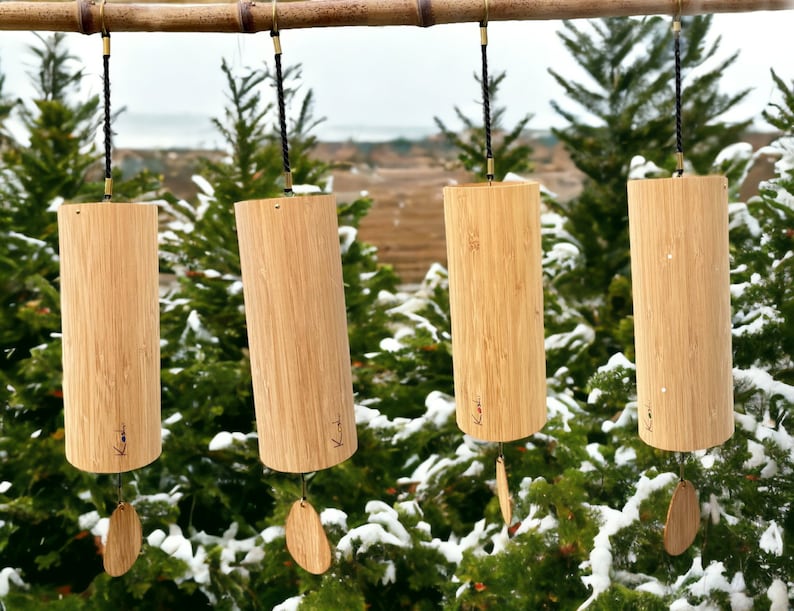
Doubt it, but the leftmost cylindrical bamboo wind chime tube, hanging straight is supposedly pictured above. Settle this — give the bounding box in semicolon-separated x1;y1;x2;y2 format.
58;203;161;473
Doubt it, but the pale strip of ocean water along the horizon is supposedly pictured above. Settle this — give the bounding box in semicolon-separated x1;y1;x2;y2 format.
113;112;437;149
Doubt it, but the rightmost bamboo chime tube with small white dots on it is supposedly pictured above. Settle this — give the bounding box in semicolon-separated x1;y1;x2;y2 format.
628;176;733;452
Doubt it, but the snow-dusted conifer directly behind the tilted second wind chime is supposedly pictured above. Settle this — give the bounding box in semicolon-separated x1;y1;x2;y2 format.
124;58;406;608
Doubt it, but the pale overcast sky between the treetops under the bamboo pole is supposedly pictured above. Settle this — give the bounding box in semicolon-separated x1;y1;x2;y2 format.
0;11;794;146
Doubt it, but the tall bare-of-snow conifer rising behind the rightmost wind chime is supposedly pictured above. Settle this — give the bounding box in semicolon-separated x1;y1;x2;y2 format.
550;16;748;376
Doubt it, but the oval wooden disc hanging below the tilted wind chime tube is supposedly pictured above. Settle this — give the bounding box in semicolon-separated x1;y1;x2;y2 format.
285;499;331;575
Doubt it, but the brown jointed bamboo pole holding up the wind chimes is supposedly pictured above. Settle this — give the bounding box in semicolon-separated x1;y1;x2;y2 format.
0;0;794;34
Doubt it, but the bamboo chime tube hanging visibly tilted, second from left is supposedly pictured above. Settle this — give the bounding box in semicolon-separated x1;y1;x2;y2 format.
234;195;358;473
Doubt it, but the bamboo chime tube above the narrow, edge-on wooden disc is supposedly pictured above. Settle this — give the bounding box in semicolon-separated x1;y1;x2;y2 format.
444;182;546;441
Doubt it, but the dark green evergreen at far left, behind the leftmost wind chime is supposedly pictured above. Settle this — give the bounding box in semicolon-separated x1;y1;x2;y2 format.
0;34;162;608
